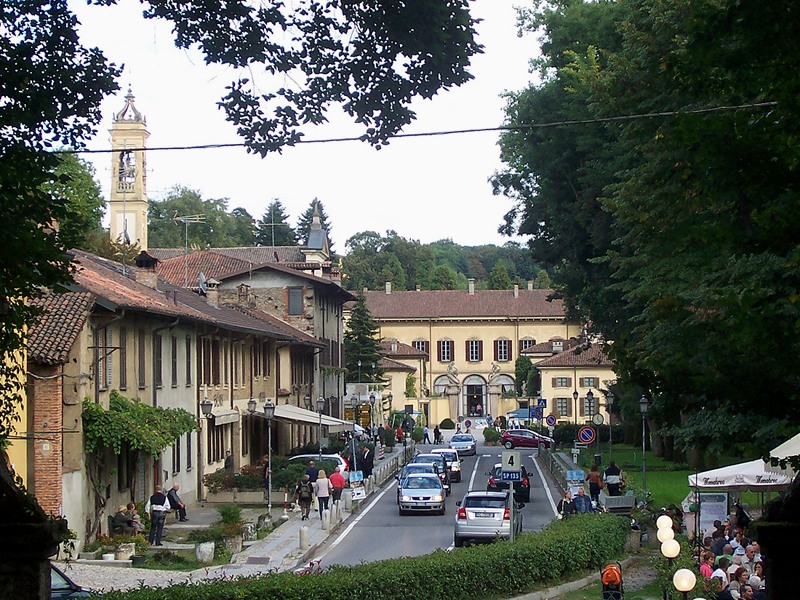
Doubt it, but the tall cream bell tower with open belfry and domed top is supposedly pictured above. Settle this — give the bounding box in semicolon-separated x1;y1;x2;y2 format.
109;88;150;250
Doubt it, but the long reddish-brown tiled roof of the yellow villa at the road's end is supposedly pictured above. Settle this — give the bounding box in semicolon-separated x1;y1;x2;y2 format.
365;290;565;320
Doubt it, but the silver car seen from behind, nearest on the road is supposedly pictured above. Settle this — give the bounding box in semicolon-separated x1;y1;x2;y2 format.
453;490;524;548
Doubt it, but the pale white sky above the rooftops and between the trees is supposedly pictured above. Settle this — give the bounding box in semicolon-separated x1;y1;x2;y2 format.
70;0;537;253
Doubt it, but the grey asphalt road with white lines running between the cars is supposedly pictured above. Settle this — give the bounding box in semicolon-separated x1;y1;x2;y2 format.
315;446;559;567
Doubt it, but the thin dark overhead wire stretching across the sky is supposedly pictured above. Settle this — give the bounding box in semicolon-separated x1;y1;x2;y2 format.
53;102;778;154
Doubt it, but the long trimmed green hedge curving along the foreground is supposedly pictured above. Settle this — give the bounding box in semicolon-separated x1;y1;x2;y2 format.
95;514;630;600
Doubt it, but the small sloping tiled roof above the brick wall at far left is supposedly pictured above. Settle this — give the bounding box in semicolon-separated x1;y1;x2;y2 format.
28;292;94;365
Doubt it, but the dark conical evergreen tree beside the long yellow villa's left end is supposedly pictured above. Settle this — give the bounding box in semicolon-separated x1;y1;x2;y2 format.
344;294;384;383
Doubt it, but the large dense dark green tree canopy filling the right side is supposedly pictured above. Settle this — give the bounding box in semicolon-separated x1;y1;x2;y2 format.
493;0;800;452
